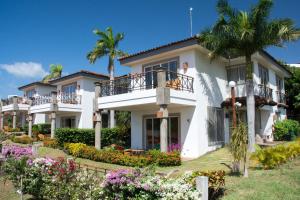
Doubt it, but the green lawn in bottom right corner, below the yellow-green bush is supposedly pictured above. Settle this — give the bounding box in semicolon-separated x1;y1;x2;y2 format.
222;157;300;200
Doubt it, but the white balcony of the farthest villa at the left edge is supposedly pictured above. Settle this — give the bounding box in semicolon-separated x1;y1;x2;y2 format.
1;96;29;112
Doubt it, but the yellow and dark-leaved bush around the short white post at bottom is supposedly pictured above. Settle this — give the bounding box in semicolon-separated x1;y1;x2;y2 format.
188;170;225;199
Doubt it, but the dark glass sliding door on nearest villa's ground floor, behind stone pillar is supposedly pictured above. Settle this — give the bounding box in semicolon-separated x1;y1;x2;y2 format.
144;116;180;149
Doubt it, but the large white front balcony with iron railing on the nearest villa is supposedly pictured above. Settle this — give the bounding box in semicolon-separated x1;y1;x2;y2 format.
98;71;196;110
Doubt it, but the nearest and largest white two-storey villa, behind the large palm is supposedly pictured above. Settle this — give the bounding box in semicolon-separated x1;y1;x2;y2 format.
96;37;290;158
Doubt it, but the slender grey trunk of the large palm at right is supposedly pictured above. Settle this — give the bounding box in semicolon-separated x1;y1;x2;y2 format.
244;55;255;176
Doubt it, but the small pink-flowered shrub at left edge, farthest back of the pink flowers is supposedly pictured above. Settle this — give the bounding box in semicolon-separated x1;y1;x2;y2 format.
1;145;32;158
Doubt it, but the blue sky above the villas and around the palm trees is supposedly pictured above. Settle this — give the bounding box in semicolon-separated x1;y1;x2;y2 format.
0;0;300;97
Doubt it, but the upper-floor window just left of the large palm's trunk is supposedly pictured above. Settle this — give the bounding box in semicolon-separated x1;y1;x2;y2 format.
227;65;246;84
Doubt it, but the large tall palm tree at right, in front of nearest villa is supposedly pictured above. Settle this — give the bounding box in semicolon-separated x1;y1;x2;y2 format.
199;0;300;176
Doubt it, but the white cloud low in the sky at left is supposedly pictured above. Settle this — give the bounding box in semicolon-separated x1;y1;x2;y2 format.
0;62;47;78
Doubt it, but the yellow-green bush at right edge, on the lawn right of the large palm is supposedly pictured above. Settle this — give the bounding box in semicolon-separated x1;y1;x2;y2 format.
251;141;300;169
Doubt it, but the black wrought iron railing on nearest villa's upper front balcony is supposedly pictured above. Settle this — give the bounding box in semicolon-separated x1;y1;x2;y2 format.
100;71;194;97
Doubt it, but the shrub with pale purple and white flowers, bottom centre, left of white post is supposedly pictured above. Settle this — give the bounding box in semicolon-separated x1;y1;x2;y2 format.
99;169;200;200
